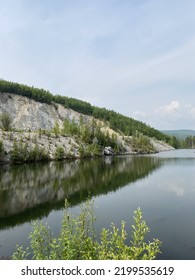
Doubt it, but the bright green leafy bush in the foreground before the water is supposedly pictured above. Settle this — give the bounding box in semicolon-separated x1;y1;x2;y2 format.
13;201;161;260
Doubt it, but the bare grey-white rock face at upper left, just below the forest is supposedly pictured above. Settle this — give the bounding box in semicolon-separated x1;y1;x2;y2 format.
0;92;90;131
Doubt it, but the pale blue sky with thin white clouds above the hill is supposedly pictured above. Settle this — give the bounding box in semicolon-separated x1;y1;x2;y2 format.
0;0;195;130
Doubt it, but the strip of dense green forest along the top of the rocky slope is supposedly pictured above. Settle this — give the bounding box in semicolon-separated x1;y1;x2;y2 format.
0;80;171;143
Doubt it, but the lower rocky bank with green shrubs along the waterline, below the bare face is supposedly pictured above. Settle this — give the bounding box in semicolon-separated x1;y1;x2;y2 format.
0;110;174;163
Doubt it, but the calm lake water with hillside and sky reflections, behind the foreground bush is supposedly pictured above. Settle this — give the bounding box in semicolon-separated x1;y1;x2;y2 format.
0;150;195;260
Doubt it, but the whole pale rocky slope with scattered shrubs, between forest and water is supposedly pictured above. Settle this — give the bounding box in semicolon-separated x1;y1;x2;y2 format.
0;92;173;164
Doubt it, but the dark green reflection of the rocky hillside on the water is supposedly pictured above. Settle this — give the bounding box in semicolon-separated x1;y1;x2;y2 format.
0;156;160;228
